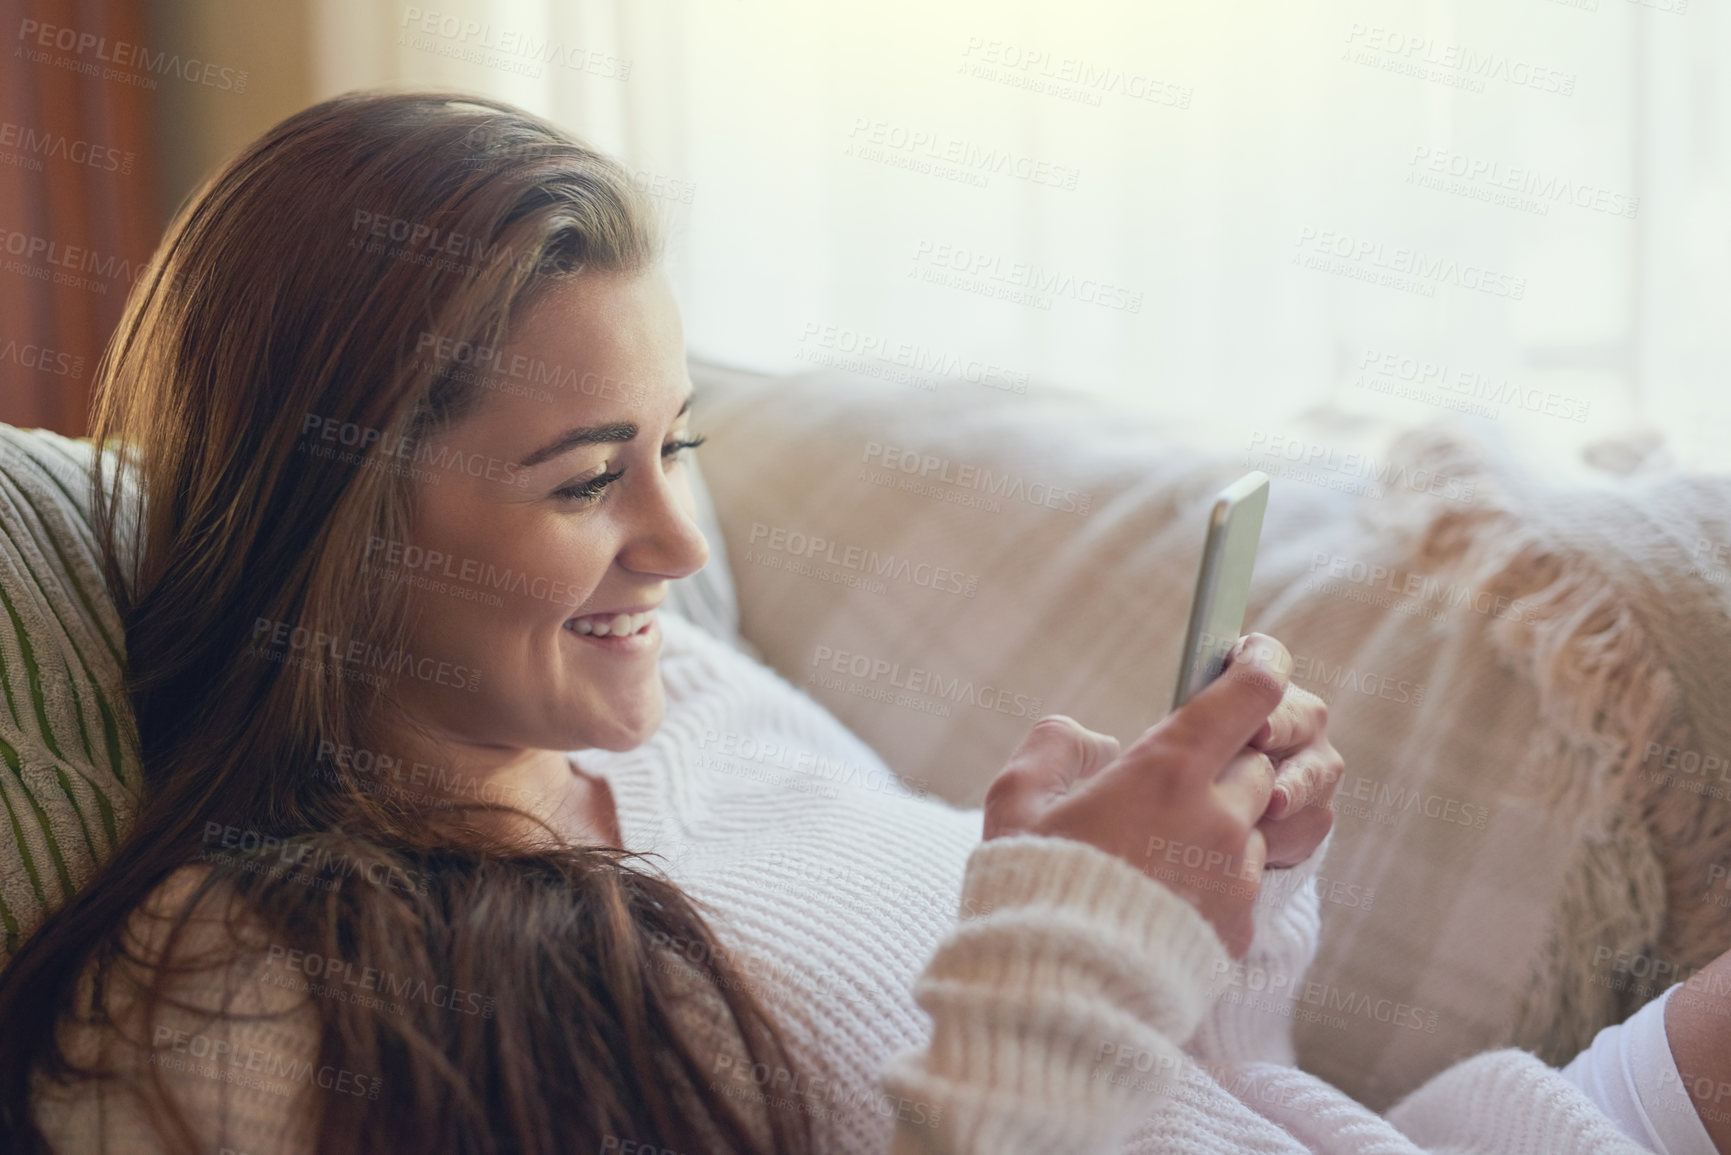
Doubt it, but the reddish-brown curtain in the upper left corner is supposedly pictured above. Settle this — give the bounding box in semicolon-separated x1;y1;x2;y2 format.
0;0;159;436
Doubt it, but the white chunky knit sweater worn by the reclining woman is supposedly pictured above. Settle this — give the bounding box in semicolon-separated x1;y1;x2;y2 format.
30;613;1643;1155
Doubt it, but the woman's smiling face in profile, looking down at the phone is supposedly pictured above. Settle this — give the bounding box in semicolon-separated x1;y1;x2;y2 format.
391;270;710;758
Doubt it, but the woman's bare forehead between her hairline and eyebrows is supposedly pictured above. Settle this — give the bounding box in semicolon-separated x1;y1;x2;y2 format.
464;268;691;442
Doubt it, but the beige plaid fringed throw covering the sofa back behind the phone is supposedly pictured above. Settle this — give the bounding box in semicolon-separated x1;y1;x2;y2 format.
696;369;1731;1107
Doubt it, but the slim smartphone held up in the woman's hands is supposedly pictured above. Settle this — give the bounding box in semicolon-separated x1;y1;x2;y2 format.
1172;469;1269;710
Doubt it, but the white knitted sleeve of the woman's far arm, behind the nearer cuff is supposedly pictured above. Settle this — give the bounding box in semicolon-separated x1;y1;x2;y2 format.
1189;831;1335;1067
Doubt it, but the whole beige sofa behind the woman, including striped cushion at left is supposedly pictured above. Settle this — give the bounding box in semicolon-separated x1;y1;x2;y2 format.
0;360;1731;1108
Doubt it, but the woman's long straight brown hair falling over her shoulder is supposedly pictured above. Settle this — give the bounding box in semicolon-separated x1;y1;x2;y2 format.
0;92;812;1155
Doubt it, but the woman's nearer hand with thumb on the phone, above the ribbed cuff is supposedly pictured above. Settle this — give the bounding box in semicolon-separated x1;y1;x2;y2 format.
983;634;1305;958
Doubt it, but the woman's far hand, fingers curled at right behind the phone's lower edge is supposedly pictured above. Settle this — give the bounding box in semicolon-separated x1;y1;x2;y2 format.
1250;686;1347;868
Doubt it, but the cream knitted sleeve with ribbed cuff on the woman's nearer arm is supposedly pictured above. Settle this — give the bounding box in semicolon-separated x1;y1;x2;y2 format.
879;835;1229;1155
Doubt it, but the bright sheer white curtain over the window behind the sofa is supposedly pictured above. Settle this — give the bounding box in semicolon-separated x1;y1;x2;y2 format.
313;0;1731;468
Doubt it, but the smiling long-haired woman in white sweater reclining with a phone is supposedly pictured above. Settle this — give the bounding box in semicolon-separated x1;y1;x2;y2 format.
0;94;1700;1155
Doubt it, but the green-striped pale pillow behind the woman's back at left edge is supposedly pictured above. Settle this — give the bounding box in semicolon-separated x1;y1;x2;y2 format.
0;424;144;966
